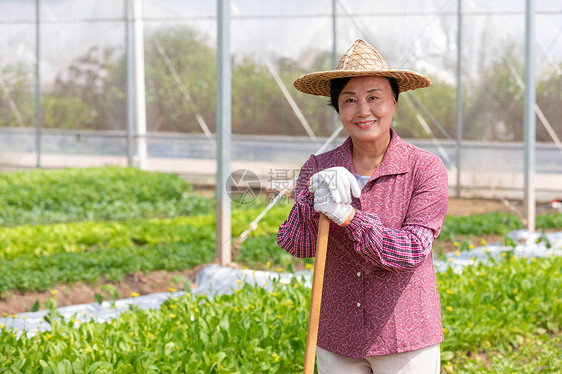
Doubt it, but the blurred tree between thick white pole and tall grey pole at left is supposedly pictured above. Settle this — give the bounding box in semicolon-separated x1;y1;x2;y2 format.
141;26;216;133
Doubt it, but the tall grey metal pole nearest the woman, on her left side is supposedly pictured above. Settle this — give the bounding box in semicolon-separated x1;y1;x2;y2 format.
216;0;232;265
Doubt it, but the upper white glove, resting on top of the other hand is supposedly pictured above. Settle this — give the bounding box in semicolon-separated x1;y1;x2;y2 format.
309;166;361;204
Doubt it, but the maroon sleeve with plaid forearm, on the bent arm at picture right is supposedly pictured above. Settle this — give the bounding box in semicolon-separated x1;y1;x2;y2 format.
344;158;448;271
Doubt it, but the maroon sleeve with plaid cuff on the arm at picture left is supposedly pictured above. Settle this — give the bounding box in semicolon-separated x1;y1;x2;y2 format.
277;156;320;258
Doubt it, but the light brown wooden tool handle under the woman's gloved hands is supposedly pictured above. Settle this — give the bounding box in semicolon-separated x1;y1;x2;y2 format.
304;213;330;374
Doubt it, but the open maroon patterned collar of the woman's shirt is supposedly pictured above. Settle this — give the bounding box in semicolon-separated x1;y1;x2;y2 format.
334;129;411;180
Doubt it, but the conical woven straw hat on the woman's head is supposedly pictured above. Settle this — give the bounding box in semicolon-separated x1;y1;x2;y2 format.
293;39;431;97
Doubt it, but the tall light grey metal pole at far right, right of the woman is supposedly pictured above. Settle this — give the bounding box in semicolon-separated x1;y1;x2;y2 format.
523;0;536;232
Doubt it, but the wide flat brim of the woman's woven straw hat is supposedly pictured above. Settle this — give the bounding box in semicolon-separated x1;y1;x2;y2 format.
293;69;431;97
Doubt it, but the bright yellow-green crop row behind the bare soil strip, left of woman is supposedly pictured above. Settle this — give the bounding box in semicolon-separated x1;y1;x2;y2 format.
0;206;290;295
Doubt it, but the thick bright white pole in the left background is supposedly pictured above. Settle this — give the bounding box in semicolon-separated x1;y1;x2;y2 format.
133;0;147;170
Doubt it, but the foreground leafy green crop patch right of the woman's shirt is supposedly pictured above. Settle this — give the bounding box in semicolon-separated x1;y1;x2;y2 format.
437;253;562;372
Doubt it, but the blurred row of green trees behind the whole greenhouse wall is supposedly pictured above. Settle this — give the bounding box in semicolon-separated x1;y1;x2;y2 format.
0;25;562;141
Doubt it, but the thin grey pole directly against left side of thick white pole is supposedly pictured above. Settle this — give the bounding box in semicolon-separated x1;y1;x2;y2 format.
125;0;135;167
